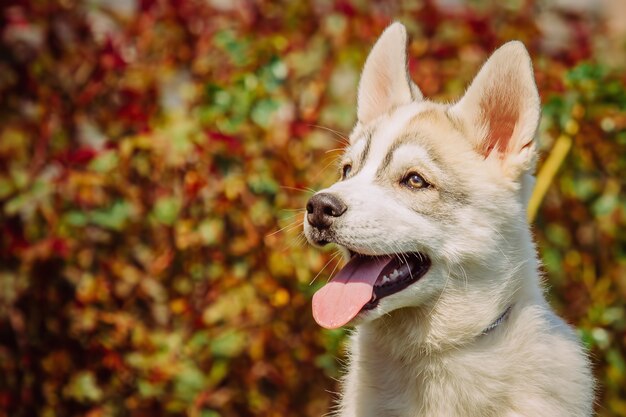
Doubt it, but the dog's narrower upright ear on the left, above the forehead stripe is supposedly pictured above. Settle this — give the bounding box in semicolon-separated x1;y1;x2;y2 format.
357;22;422;123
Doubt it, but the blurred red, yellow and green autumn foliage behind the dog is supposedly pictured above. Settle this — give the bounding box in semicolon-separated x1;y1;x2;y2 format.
0;0;626;417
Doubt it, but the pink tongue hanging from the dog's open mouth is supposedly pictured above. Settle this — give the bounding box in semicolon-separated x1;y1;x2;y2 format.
313;256;391;329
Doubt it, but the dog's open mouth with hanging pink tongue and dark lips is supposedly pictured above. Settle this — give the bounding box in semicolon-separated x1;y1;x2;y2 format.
313;253;430;329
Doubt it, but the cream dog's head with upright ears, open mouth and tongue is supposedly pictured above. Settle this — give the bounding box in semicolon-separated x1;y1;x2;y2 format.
304;23;540;334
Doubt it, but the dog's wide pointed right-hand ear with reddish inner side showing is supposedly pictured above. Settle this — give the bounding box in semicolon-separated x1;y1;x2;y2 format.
449;41;541;177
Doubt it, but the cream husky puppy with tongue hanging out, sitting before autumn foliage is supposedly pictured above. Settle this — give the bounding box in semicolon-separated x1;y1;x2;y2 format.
304;23;594;417
